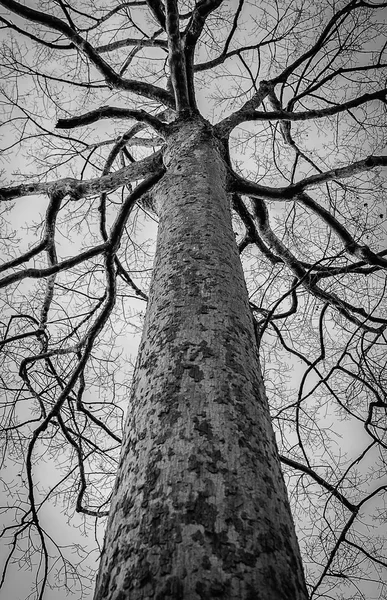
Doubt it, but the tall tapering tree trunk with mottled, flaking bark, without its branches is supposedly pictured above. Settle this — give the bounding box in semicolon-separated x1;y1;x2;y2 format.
95;121;307;600
